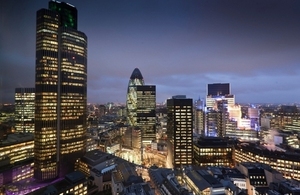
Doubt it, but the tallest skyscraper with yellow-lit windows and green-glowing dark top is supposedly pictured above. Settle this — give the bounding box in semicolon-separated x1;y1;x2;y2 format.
34;1;87;180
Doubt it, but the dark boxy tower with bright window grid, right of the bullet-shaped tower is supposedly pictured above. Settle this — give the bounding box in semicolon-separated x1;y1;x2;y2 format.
167;95;193;168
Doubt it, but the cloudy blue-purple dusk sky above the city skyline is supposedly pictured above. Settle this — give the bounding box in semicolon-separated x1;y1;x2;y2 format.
0;0;300;103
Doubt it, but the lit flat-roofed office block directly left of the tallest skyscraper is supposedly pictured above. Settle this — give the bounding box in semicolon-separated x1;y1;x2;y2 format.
15;88;35;133
